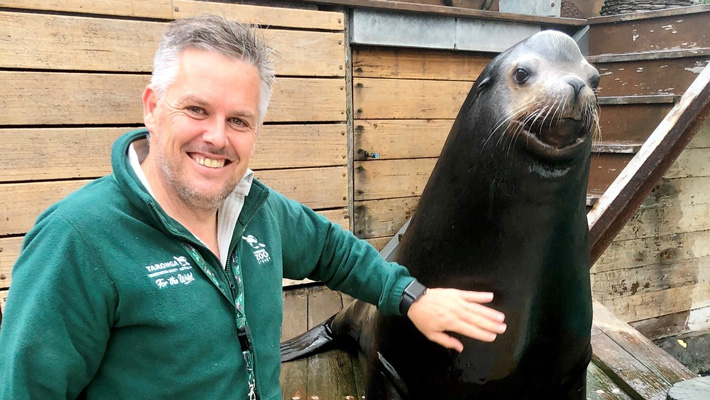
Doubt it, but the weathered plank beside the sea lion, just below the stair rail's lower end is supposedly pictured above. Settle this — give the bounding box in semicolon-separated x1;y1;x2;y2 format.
591;256;710;301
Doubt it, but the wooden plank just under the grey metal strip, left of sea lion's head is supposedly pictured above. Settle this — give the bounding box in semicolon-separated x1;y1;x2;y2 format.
353;46;493;81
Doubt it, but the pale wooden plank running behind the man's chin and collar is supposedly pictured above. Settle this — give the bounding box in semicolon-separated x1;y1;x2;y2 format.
0;166;348;235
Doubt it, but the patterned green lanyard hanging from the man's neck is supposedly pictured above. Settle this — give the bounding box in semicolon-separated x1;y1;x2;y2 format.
183;242;260;400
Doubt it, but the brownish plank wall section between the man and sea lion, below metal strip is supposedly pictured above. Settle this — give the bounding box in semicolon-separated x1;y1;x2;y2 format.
353;47;494;249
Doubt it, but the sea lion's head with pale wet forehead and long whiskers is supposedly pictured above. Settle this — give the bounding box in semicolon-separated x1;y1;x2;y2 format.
467;31;599;164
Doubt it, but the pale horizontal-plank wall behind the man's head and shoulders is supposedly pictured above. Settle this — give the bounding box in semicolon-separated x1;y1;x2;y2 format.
0;0;350;307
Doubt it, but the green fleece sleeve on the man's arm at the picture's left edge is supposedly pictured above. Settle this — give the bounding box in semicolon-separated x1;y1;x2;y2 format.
0;215;115;400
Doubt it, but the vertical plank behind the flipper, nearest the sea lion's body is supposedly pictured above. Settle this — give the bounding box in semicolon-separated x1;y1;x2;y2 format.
307;290;357;399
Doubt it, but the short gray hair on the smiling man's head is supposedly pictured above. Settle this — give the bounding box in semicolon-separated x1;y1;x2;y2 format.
150;15;275;123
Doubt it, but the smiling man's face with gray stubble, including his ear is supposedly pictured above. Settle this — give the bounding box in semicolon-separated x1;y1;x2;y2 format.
143;49;260;211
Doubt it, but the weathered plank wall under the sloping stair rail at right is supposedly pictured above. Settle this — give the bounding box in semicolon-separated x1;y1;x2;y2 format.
591;119;710;338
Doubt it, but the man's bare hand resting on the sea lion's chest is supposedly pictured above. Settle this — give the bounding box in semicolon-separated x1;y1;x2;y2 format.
407;289;506;353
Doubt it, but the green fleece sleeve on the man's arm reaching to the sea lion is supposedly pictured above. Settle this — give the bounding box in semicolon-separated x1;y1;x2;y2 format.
281;195;413;315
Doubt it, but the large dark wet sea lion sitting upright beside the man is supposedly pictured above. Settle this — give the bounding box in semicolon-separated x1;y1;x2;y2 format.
282;31;599;400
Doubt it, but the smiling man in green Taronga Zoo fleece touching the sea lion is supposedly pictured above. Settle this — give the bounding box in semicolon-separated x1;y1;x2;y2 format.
0;17;505;400
